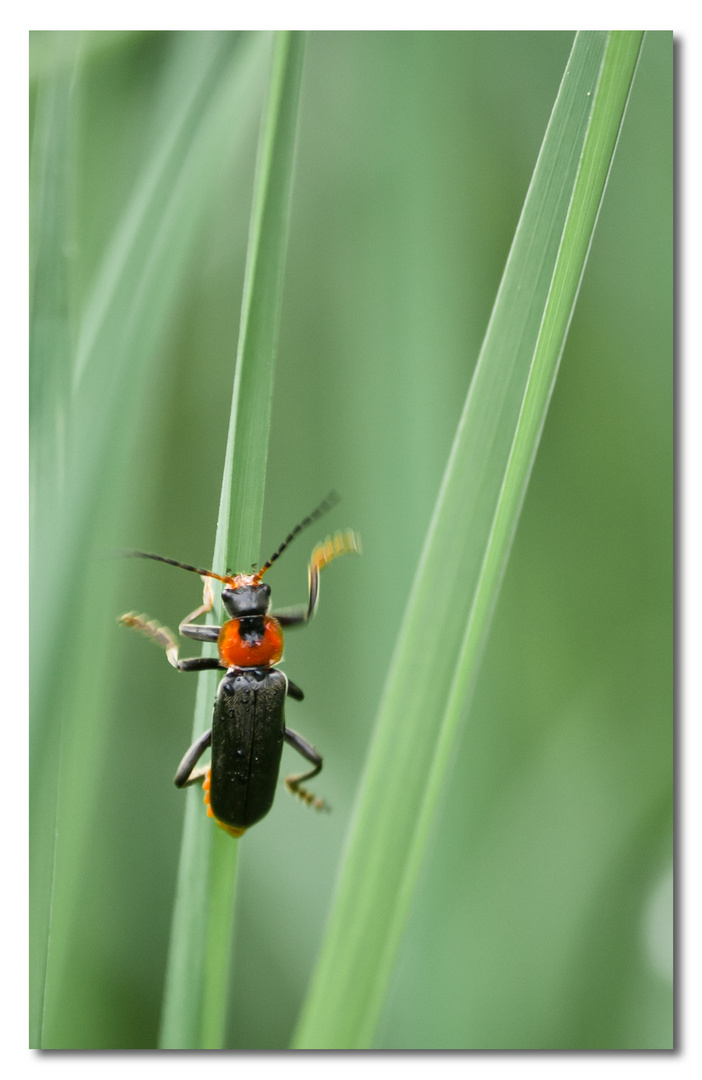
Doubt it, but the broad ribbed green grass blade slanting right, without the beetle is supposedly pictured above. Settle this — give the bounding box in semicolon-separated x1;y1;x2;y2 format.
295;32;643;1049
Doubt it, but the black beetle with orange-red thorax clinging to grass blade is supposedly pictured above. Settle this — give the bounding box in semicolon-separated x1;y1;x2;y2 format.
119;495;361;837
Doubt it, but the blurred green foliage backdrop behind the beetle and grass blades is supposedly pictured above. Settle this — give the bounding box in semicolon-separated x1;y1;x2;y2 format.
30;32;673;1049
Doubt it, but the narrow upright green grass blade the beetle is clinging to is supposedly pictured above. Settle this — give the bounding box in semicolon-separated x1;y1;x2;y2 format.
160;32;305;1050
